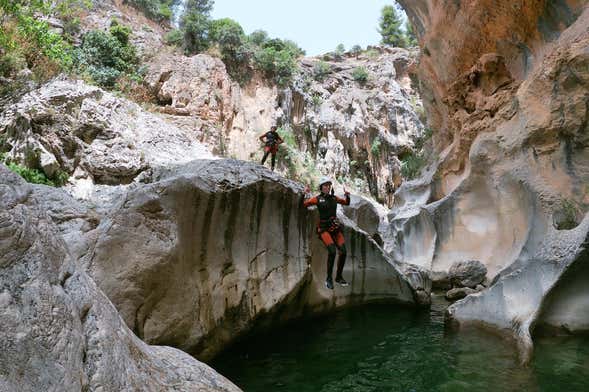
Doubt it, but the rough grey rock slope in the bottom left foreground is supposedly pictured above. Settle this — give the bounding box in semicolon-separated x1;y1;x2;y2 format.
0;164;239;392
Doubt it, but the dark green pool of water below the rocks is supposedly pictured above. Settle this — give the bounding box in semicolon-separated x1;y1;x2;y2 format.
212;300;589;392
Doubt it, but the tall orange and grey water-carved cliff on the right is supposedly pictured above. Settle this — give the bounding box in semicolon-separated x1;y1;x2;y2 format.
392;0;589;361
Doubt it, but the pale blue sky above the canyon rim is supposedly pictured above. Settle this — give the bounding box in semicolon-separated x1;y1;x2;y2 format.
211;0;393;56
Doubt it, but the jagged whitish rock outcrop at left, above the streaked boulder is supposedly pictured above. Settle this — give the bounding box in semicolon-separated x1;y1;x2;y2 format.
0;80;212;197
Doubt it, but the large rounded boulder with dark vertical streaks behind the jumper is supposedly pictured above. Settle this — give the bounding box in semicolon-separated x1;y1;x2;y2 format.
82;160;418;358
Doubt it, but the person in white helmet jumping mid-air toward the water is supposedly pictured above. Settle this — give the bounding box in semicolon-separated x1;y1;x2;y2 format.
303;177;350;290
